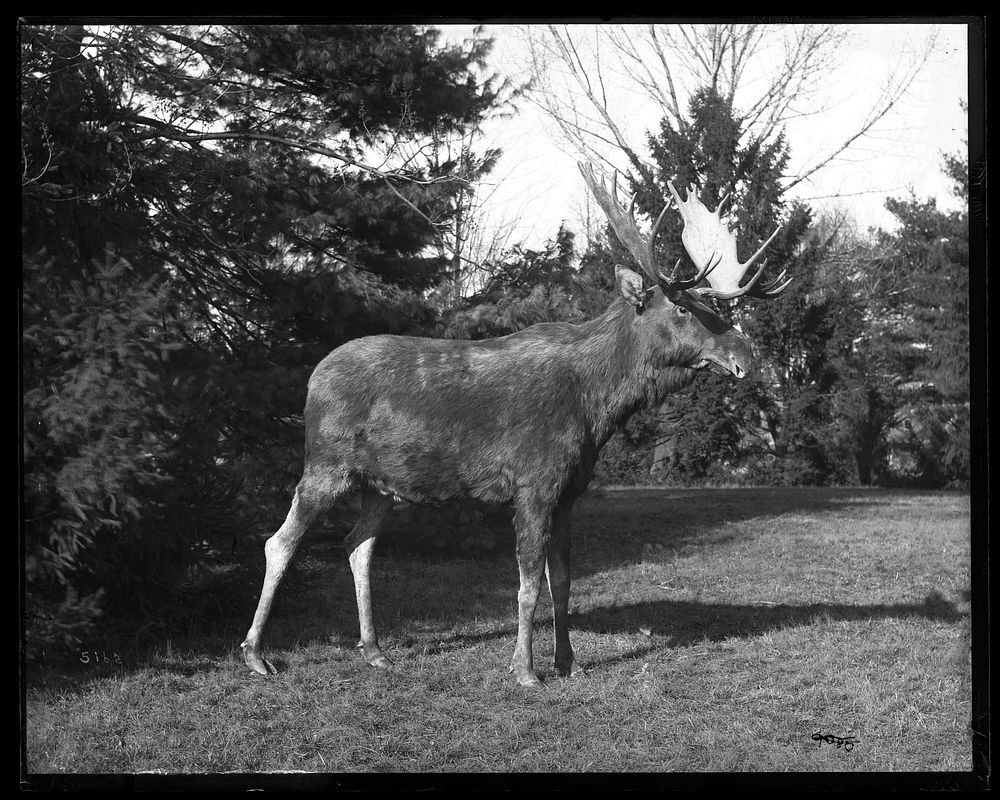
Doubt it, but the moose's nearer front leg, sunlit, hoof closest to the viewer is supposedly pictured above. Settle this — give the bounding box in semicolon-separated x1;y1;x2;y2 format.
510;496;552;689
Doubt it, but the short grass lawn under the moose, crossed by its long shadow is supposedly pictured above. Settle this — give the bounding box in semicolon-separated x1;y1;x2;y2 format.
25;489;972;787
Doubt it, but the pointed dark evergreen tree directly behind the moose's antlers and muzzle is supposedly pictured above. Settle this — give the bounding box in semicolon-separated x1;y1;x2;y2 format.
633;88;842;483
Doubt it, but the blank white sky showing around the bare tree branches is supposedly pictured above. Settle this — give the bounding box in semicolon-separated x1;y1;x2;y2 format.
443;24;968;246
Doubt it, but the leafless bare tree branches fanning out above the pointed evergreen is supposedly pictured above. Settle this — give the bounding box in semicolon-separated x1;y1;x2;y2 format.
522;23;933;200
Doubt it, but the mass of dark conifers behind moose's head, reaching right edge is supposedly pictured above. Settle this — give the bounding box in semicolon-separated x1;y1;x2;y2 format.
580;88;969;488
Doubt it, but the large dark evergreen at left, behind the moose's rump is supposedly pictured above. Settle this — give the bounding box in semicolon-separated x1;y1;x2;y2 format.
20;25;508;638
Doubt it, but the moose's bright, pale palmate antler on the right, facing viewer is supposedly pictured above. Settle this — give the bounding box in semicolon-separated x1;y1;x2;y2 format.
667;181;792;300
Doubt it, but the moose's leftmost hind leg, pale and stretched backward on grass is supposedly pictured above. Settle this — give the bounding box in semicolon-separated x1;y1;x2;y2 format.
240;474;350;675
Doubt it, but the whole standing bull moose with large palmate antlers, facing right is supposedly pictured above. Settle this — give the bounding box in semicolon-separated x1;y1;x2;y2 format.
241;163;791;688
